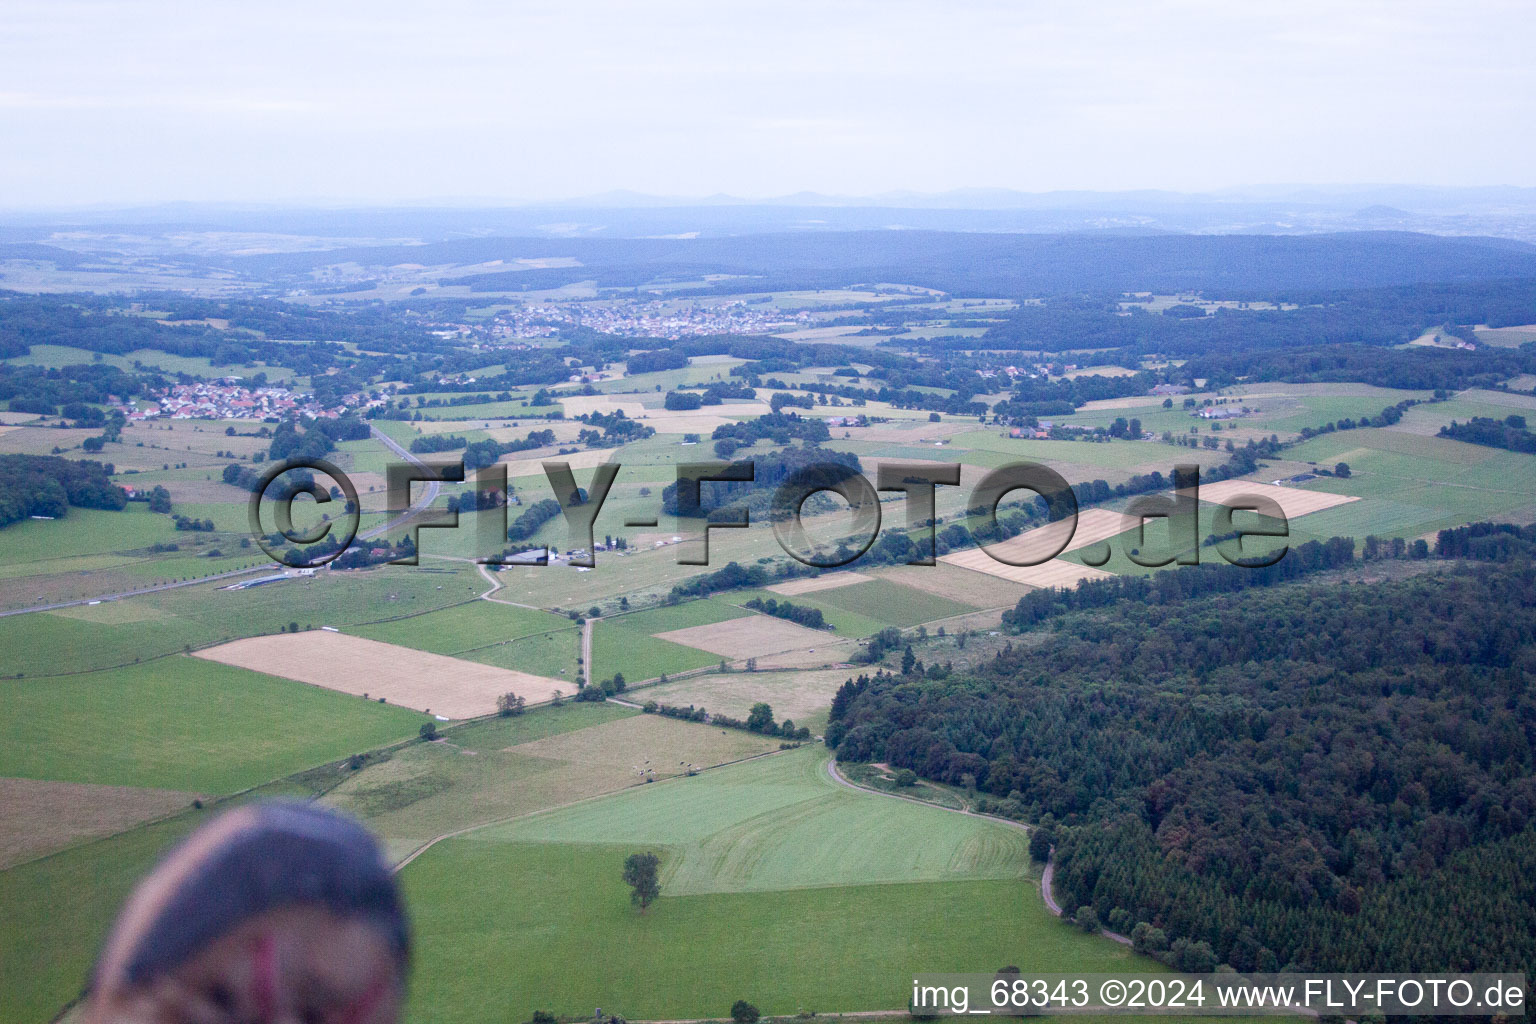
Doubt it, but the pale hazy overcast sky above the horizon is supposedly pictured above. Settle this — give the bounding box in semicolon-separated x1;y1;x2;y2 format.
0;0;1536;207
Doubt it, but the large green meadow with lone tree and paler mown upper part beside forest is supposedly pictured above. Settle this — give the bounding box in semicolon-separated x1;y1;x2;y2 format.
402;749;1155;1021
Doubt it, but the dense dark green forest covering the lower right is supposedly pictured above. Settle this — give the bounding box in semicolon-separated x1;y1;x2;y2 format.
826;561;1536;970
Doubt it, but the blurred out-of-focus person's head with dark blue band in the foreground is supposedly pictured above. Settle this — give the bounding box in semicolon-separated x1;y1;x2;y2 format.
83;803;409;1024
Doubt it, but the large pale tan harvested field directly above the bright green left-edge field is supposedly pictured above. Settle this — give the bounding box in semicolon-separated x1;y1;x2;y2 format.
197;629;576;718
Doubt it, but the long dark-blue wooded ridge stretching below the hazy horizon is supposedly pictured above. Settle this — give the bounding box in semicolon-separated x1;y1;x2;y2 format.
229;230;1536;296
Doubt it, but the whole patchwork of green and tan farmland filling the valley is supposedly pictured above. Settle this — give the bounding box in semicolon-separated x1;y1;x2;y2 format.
0;251;1536;1022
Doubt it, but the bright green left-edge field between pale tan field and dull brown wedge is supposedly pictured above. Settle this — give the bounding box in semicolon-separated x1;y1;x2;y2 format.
0;656;424;794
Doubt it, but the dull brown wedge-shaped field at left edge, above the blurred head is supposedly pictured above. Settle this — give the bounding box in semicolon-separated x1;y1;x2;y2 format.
0;778;195;869
